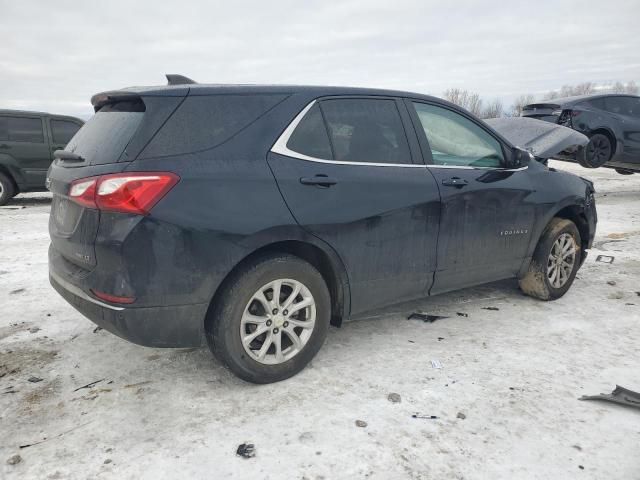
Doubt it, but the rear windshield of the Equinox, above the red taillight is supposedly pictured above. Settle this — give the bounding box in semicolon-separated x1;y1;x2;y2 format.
65;100;145;165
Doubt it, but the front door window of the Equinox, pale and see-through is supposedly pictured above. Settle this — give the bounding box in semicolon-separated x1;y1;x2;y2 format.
413;102;504;167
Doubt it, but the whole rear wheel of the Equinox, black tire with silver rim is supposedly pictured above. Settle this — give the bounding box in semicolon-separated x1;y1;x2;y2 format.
205;254;331;383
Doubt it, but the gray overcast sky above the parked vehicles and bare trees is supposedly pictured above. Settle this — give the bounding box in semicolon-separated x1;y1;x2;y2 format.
0;0;640;117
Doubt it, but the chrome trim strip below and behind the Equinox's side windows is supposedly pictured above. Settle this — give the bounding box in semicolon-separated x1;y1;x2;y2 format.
271;100;529;172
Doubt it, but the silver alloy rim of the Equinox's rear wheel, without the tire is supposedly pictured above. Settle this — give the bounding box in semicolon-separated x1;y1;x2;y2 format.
240;278;316;365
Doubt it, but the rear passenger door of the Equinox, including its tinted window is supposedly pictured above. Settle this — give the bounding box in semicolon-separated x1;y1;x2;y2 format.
268;97;440;314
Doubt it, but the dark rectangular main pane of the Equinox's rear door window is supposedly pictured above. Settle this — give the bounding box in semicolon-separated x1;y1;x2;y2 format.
320;98;411;163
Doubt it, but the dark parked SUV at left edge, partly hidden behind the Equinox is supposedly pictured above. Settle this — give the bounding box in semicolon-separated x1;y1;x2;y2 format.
0;110;84;205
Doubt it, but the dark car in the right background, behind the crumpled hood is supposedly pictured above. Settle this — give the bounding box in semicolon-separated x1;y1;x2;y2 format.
522;94;640;175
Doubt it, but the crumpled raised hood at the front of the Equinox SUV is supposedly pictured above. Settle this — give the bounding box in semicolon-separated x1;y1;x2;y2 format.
485;117;589;159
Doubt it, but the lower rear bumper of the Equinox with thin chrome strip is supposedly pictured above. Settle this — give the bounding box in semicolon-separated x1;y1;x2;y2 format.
49;270;208;347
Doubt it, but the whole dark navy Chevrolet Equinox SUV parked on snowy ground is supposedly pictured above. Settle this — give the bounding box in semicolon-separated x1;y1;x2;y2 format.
49;78;596;383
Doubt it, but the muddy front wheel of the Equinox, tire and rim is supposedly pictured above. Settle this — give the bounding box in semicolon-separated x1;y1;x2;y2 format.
520;218;582;300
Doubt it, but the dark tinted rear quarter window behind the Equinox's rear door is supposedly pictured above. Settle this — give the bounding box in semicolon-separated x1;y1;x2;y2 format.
143;94;286;157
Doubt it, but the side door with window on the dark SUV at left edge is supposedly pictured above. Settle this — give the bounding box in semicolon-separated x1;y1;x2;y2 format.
0;115;51;188
